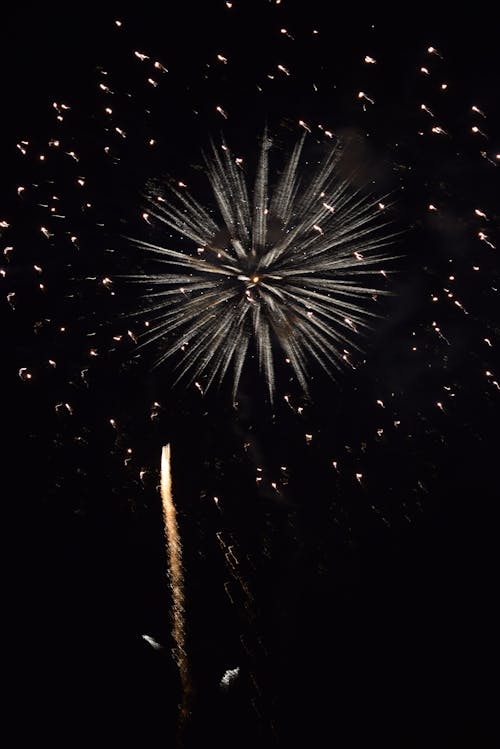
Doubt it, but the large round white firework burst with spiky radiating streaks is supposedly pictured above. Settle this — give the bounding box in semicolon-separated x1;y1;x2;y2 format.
127;133;391;400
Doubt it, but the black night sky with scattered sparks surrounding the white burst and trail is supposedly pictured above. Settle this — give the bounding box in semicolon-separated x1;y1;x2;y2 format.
0;0;500;749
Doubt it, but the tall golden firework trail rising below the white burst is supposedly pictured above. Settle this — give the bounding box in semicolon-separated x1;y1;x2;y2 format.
160;445;192;734
